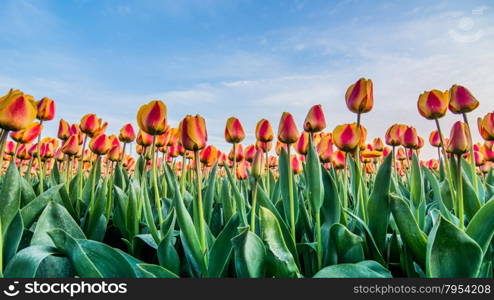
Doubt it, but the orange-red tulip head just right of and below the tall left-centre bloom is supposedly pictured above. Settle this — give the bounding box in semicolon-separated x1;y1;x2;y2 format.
180;115;208;151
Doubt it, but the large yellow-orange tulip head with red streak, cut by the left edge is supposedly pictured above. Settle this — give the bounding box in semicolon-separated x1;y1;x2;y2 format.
0;90;36;131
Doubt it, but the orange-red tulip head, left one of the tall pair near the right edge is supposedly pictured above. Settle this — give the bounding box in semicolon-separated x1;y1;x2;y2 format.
417;90;449;120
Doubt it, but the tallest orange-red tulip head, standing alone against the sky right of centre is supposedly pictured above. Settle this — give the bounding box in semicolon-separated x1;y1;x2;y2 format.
345;78;374;114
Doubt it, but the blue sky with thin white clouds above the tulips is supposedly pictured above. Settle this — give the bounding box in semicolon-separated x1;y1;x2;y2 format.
0;0;494;157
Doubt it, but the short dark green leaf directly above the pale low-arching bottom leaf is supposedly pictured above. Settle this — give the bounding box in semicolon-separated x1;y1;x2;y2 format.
329;224;365;264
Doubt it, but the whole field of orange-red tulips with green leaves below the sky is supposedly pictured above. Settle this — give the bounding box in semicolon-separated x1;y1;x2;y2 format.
0;78;494;278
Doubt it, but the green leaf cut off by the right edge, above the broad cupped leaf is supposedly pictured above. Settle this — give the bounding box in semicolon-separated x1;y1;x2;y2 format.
466;197;494;253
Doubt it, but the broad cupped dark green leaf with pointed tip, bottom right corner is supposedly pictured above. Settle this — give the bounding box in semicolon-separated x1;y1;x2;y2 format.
426;217;482;278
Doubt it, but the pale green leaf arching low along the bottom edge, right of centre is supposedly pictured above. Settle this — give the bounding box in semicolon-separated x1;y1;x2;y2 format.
314;260;392;278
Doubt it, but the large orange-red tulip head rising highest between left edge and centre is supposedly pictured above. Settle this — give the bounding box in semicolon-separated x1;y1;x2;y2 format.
137;100;167;135
